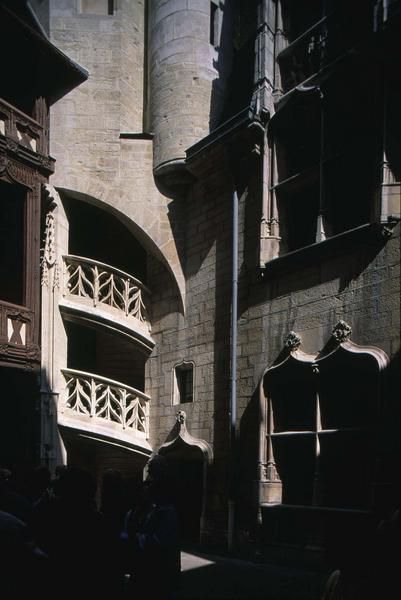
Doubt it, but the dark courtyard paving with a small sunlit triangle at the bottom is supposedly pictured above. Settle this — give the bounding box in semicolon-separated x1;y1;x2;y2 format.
176;552;325;600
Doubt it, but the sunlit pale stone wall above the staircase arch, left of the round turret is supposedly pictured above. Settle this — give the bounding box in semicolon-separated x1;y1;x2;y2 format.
46;0;184;300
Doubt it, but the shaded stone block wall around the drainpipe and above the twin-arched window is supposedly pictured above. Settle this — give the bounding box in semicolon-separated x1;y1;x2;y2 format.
148;142;400;538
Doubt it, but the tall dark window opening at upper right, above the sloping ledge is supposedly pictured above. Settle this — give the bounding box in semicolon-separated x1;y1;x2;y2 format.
269;0;382;254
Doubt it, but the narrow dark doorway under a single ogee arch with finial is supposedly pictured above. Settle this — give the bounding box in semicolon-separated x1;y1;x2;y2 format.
158;410;213;544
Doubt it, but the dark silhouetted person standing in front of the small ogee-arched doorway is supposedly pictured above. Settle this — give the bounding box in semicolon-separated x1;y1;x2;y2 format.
123;456;181;600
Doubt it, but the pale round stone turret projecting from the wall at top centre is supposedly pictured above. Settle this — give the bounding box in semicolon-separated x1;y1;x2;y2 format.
149;0;222;179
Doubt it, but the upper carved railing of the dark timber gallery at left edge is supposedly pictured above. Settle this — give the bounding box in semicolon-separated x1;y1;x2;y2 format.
0;98;45;153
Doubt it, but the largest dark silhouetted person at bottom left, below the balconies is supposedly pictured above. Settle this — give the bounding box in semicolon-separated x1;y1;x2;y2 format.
35;468;112;598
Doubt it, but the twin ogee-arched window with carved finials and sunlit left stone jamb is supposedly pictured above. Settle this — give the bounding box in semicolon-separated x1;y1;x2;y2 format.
259;321;388;510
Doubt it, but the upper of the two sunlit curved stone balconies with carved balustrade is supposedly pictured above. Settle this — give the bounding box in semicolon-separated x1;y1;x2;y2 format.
59;255;154;352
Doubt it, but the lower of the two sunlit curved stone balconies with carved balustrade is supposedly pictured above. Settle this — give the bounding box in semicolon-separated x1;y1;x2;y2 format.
58;369;150;451
